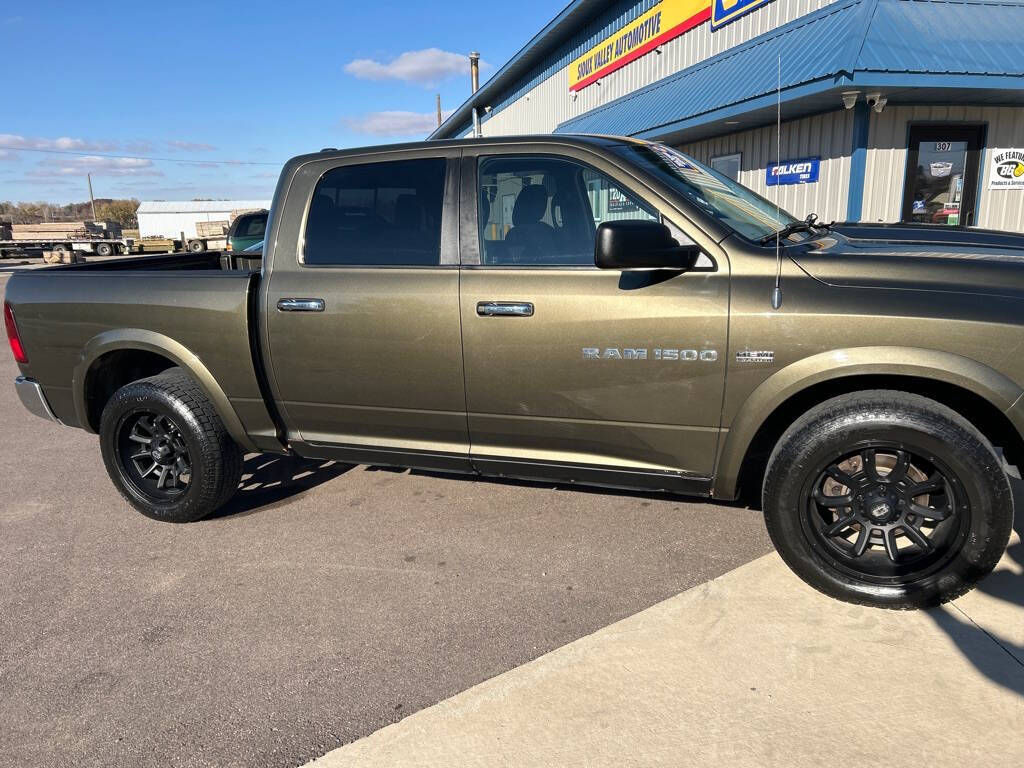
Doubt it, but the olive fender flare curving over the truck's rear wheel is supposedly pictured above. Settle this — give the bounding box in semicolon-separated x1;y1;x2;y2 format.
72;328;257;452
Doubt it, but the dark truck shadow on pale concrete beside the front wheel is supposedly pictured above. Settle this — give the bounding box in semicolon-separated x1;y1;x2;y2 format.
927;477;1024;696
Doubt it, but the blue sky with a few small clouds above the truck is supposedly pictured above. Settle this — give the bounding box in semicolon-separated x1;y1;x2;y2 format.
0;0;564;203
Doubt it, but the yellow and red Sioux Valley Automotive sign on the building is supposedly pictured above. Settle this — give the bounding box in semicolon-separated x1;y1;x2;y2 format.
569;0;722;91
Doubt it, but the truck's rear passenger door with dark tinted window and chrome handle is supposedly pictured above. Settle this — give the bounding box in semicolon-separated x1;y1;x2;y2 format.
266;157;469;469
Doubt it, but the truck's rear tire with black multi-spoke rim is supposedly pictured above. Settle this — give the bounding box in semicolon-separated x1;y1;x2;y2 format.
99;368;242;522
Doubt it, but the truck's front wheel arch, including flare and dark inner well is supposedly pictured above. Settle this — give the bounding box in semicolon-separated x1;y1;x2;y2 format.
713;347;1024;499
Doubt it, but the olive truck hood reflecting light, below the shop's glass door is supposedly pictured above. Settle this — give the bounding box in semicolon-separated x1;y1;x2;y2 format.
786;224;1024;298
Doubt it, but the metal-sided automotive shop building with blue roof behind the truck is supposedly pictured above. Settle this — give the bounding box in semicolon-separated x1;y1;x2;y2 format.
432;0;1024;231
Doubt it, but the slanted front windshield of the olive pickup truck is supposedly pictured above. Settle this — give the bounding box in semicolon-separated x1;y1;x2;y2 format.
613;143;797;241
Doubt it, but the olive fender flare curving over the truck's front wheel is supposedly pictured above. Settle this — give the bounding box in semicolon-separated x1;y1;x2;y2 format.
713;346;1024;499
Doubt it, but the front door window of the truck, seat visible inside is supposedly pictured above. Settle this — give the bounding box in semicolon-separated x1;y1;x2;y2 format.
479;156;657;266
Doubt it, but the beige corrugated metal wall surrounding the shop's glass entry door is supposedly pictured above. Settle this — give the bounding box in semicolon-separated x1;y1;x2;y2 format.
863;106;1024;231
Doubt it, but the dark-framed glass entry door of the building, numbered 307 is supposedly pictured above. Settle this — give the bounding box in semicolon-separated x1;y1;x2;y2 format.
902;125;984;226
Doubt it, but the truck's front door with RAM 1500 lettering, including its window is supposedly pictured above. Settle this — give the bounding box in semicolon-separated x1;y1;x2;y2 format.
462;155;728;482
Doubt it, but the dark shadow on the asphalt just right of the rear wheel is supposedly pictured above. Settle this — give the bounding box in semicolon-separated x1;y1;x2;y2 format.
207;454;353;520
